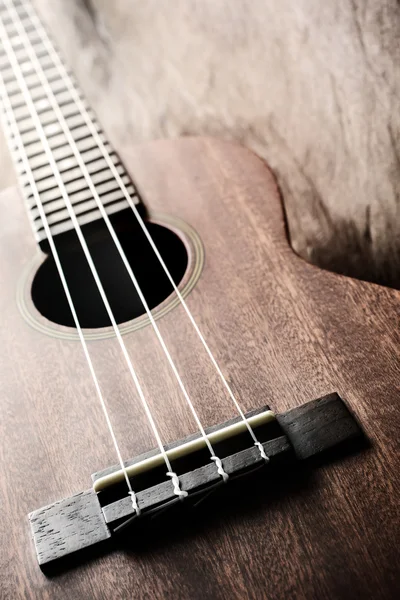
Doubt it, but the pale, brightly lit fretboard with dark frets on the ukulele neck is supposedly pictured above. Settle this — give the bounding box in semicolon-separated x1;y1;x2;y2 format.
0;0;139;243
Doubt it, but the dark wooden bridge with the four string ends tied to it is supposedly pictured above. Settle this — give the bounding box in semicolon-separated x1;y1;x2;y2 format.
29;394;362;566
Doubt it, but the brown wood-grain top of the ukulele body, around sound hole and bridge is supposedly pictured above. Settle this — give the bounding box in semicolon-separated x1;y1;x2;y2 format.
0;139;400;600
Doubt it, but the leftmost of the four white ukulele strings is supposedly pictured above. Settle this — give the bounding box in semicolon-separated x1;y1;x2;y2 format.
0;50;140;515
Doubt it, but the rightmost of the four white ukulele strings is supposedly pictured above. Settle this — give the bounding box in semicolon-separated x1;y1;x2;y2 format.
18;0;269;462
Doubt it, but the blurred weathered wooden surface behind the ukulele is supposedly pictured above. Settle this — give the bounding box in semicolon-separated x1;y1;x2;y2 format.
0;0;400;287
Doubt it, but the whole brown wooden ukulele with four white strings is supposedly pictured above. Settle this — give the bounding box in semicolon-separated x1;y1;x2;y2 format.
0;0;400;600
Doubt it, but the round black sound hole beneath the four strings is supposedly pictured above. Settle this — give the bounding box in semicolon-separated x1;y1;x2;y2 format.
32;213;188;328
